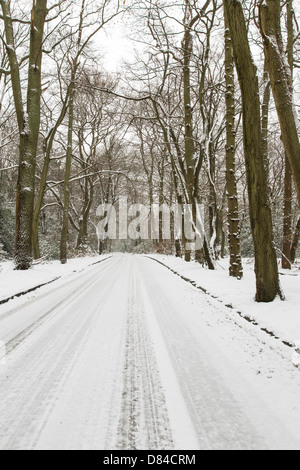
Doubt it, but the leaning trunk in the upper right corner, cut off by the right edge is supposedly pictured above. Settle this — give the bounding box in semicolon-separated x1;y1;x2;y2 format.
260;0;300;205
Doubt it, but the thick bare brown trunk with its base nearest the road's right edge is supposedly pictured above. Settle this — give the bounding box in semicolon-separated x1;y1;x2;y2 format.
224;0;282;302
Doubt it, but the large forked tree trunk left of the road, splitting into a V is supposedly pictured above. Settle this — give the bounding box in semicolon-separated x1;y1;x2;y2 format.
1;0;47;270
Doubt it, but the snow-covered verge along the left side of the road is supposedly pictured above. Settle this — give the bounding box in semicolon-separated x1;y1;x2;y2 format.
0;255;110;302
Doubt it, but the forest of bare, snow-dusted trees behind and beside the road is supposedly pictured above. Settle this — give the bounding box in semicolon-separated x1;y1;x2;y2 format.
0;0;300;302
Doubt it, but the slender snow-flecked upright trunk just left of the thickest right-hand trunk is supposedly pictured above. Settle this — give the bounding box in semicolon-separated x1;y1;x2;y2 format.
224;9;243;279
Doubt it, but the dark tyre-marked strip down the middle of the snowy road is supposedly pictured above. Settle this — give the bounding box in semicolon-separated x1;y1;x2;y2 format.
117;261;174;450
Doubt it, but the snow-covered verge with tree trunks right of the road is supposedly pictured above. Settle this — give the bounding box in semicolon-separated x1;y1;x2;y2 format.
150;255;300;352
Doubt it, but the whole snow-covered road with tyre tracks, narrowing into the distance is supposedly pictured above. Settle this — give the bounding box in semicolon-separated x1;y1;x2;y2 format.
0;255;300;450
